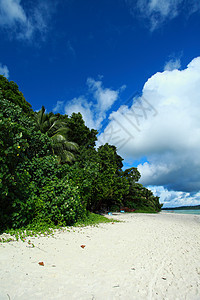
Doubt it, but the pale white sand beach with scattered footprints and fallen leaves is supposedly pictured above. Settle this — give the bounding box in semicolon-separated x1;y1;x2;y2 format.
0;213;200;300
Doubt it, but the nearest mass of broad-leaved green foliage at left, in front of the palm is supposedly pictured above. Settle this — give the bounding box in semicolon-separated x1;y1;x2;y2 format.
0;99;84;228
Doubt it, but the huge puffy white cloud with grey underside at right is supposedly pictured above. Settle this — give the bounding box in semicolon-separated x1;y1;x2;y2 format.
99;57;200;192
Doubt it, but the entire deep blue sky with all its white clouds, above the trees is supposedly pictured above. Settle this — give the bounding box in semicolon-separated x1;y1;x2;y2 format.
0;0;200;206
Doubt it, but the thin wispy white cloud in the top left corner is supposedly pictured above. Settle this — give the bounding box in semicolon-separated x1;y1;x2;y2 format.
0;0;55;40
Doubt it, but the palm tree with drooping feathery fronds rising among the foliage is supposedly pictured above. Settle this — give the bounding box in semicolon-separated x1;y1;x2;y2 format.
35;106;78;162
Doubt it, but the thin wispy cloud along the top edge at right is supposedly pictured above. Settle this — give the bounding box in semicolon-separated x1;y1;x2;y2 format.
125;0;200;31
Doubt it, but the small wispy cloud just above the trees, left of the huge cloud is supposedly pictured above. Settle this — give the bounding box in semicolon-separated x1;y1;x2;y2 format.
65;78;121;129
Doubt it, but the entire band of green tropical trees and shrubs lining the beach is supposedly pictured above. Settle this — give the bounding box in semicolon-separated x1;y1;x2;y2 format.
0;76;162;231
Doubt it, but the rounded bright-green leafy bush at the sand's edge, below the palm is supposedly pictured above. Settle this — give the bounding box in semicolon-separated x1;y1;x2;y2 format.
33;178;85;226
